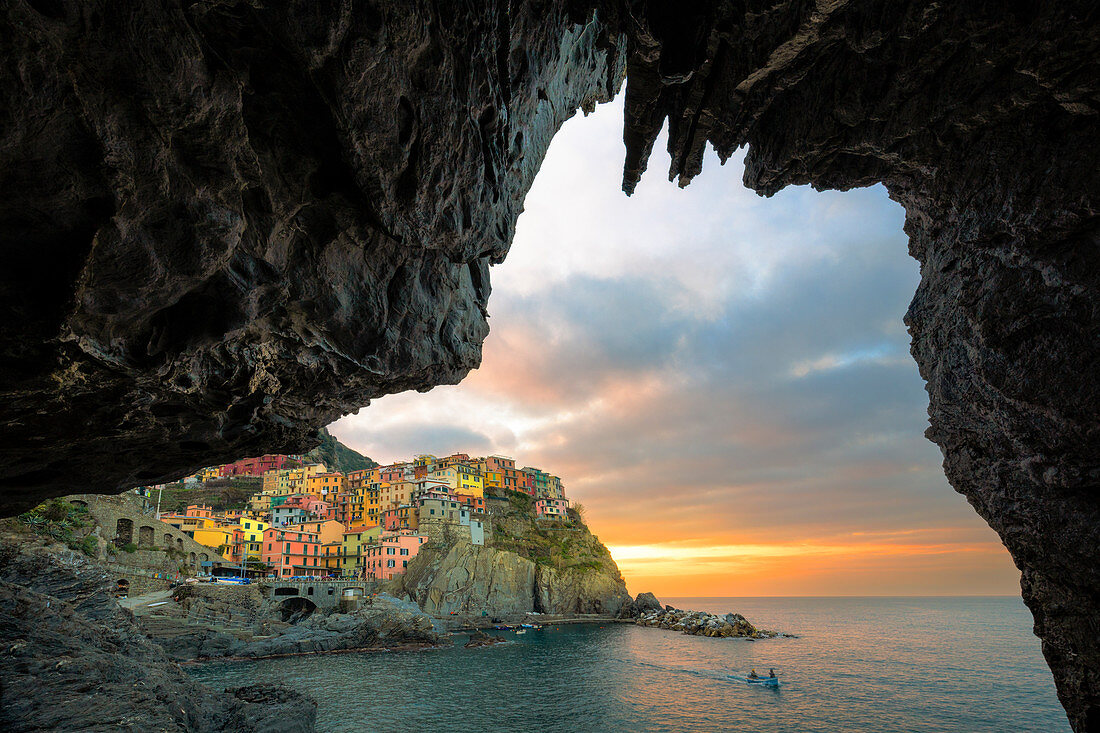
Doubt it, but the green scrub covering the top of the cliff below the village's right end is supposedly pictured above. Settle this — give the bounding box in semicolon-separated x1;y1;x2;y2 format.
488;490;613;571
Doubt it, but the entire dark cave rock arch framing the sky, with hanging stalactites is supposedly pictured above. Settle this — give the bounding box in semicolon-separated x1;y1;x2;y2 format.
0;0;1100;731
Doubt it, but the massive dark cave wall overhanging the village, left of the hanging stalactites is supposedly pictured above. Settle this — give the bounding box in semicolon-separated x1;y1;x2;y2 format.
0;0;624;513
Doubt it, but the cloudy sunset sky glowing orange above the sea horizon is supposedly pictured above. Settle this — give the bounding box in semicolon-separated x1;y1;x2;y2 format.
331;97;1020;597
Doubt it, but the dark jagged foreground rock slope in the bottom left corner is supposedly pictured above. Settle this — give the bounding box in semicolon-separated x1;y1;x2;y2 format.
0;534;317;733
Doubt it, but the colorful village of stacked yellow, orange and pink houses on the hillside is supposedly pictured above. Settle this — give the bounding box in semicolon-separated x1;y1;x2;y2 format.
150;453;569;580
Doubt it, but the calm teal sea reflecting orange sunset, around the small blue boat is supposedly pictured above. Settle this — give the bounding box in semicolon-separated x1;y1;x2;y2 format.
189;598;1069;733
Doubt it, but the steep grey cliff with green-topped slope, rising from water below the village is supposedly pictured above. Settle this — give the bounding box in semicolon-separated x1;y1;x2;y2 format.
388;492;631;616
